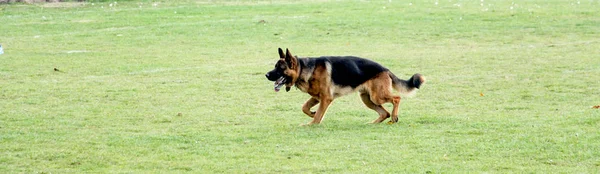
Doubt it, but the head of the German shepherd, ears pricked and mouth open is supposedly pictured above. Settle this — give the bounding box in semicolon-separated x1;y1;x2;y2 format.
265;48;300;92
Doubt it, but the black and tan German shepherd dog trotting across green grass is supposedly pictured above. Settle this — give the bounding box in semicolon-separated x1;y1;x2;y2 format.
266;48;425;125
